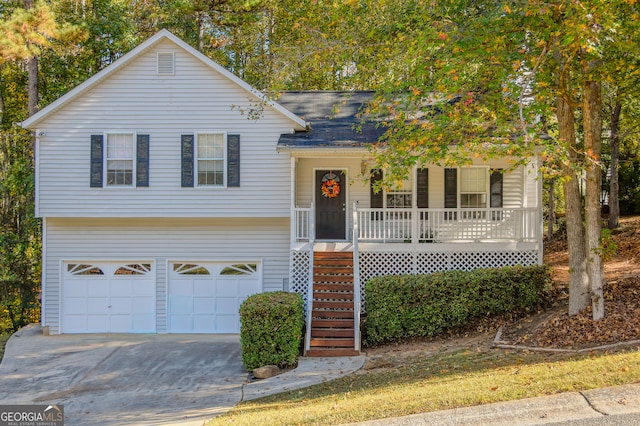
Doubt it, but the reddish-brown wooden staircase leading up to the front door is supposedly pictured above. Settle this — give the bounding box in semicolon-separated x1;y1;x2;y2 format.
306;252;360;357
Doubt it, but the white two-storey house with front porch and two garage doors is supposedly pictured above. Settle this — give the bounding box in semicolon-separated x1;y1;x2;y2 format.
22;30;542;355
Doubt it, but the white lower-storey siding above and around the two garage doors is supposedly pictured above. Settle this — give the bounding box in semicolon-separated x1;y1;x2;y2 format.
43;218;289;334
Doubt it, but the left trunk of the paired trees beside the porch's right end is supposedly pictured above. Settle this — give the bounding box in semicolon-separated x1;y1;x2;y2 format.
556;96;590;315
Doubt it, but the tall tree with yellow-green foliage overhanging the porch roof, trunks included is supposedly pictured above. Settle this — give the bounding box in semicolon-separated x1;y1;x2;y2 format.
368;0;638;319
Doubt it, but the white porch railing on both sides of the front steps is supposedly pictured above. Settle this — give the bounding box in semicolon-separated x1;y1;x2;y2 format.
294;208;540;243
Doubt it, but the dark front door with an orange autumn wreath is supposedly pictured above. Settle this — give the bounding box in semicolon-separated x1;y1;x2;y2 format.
315;170;347;240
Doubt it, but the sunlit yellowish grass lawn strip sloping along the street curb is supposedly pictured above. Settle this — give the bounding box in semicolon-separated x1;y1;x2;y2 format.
207;348;640;426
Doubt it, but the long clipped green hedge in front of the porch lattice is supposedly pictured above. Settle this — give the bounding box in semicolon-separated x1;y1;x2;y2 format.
363;266;551;346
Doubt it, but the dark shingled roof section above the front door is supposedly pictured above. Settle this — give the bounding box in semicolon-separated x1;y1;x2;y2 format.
276;91;386;150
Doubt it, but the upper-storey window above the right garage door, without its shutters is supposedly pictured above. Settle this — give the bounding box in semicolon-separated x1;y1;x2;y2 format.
196;133;225;186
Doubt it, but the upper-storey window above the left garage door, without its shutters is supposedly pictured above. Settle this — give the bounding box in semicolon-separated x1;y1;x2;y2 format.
106;133;134;186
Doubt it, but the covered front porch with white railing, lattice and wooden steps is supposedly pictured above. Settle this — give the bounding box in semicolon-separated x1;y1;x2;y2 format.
289;157;542;356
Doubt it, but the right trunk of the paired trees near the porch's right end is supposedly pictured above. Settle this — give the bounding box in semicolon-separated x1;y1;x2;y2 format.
582;81;604;321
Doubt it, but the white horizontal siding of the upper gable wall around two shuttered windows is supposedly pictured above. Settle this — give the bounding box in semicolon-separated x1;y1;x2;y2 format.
37;40;295;217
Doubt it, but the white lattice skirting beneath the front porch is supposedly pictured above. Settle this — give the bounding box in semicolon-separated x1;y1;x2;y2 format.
289;250;538;304
